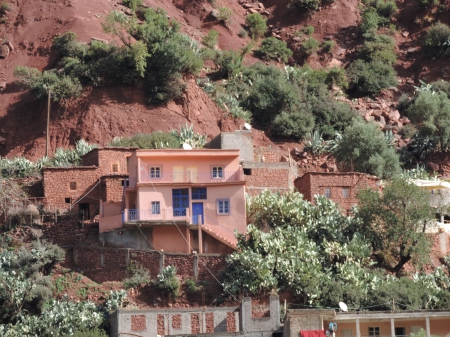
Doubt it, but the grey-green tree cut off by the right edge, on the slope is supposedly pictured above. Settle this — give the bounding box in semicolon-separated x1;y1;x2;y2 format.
407;91;450;151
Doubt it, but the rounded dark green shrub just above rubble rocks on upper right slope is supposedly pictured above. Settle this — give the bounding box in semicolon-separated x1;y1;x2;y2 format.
347;60;397;95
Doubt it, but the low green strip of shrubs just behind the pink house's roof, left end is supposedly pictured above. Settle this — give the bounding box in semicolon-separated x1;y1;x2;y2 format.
108;131;180;149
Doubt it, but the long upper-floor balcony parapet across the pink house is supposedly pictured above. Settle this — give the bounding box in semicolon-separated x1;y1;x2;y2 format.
138;170;244;187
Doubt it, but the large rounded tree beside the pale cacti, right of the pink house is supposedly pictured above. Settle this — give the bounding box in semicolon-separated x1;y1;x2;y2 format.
355;178;435;276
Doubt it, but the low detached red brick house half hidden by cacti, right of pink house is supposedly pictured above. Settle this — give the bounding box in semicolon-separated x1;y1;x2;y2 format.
294;172;379;212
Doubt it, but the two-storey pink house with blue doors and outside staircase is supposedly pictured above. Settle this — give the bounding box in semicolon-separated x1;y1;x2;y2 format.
99;149;246;253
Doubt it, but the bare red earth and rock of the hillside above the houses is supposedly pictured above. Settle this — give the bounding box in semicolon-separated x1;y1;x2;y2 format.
0;0;450;158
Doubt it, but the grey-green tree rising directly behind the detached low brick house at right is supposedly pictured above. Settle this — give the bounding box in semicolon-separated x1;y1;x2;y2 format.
334;119;400;178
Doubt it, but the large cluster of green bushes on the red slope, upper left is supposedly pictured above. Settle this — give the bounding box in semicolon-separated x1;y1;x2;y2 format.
15;8;203;103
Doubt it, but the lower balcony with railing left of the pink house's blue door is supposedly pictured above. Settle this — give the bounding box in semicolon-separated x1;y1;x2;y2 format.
122;208;191;224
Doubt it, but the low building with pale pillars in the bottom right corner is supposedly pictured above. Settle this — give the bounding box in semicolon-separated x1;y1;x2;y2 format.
284;309;450;337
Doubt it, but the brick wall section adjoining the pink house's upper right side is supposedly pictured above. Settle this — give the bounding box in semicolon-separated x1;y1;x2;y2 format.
242;162;296;195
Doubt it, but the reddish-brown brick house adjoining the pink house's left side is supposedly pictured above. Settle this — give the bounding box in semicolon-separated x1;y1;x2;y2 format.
43;148;135;219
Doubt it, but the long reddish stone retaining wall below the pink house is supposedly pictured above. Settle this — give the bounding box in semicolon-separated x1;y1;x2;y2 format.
73;244;226;283
